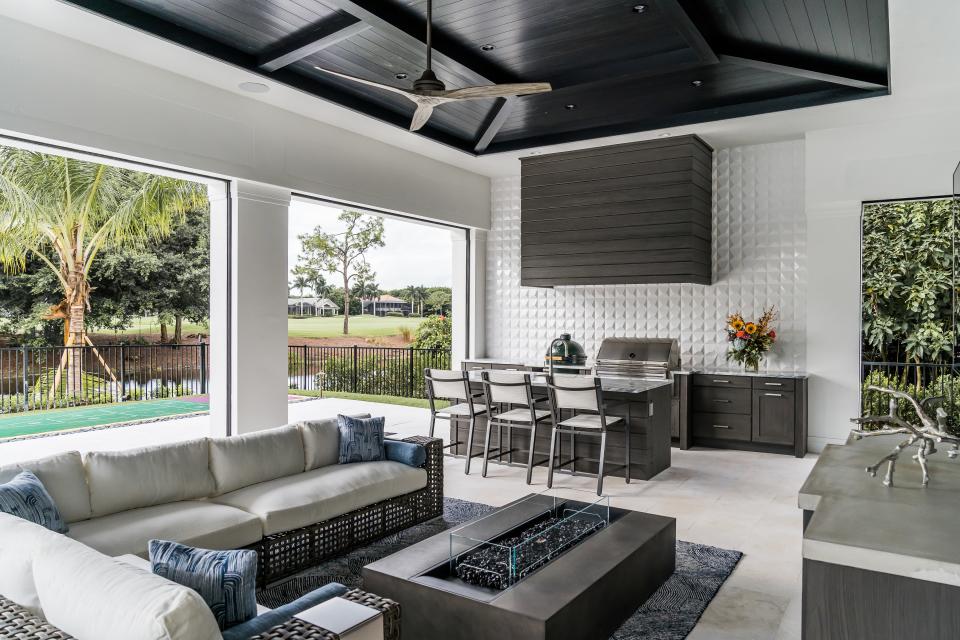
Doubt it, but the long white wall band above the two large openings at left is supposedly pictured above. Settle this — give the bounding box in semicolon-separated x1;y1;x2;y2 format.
0;13;490;227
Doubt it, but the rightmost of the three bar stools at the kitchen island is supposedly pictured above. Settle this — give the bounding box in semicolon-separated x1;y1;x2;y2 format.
547;376;630;496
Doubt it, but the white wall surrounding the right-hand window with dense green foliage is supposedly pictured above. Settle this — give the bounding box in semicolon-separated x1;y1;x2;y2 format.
806;111;960;450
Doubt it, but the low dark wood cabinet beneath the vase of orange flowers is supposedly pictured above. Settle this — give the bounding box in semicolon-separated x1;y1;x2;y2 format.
681;373;807;457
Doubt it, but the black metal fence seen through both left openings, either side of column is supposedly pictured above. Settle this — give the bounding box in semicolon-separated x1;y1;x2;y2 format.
0;343;450;413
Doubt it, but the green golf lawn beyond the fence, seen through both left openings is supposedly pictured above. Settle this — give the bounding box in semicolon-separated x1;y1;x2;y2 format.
97;315;424;338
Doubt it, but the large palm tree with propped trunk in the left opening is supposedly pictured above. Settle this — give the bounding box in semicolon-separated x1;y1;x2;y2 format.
0;147;207;400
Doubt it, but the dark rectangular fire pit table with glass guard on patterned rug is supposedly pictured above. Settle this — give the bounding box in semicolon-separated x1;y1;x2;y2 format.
363;492;676;640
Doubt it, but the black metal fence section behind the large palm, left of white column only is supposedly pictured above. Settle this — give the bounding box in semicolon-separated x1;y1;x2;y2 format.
0;343;209;413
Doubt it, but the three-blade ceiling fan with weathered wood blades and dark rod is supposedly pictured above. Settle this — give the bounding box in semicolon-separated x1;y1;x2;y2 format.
314;0;553;131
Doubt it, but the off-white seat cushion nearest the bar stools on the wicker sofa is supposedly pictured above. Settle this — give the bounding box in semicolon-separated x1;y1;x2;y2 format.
213;460;427;536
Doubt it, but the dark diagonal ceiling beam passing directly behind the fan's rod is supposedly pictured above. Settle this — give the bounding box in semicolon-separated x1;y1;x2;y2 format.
324;0;522;84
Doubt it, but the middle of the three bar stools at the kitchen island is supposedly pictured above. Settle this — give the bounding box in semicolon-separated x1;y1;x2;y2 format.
480;371;550;484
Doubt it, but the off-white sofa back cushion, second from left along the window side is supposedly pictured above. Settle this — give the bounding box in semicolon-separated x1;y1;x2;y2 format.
84;438;213;517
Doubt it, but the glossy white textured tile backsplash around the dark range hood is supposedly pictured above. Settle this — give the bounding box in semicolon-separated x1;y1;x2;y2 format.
486;141;807;371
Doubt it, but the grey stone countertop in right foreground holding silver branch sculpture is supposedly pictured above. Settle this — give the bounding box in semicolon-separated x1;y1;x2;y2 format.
798;435;960;587
